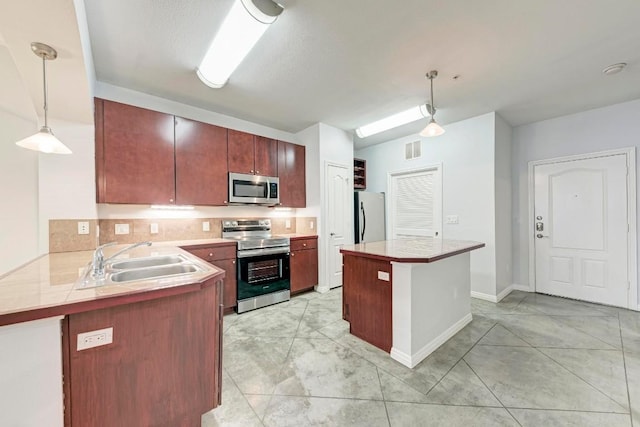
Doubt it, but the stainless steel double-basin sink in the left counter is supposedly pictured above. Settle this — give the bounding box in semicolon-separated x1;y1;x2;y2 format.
77;254;204;289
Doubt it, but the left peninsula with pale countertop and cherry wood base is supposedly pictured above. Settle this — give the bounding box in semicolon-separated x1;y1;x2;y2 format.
0;246;224;427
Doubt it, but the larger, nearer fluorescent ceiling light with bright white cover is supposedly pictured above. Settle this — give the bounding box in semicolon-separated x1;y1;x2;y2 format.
196;0;283;88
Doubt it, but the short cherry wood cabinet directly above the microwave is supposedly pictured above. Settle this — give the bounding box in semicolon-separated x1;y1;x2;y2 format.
228;129;278;176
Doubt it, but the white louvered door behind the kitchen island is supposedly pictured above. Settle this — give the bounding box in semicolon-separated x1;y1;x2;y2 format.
388;165;442;239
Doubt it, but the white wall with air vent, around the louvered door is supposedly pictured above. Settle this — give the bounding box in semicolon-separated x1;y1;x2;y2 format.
356;113;496;296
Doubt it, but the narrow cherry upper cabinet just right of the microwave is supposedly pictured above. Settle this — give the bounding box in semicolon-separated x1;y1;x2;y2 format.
278;141;307;208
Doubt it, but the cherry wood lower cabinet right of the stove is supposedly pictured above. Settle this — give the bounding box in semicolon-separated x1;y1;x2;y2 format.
289;236;318;294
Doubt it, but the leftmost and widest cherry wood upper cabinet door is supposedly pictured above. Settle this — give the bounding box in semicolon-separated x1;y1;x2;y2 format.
95;99;175;204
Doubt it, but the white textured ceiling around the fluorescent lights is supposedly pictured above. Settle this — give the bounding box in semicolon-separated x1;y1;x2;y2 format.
5;0;640;146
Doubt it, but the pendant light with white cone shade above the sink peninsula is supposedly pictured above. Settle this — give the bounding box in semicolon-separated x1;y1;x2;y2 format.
16;42;71;154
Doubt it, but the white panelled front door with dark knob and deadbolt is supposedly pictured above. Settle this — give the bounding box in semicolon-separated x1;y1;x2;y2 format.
532;154;629;307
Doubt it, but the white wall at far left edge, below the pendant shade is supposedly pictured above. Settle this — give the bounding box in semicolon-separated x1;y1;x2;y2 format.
0;109;38;275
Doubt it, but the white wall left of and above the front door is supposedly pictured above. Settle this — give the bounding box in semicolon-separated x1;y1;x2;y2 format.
512;100;640;304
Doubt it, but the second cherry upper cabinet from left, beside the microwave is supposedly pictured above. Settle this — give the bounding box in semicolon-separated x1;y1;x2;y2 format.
175;117;229;206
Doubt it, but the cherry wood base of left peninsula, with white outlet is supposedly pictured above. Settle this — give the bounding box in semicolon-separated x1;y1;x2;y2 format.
63;281;222;427
